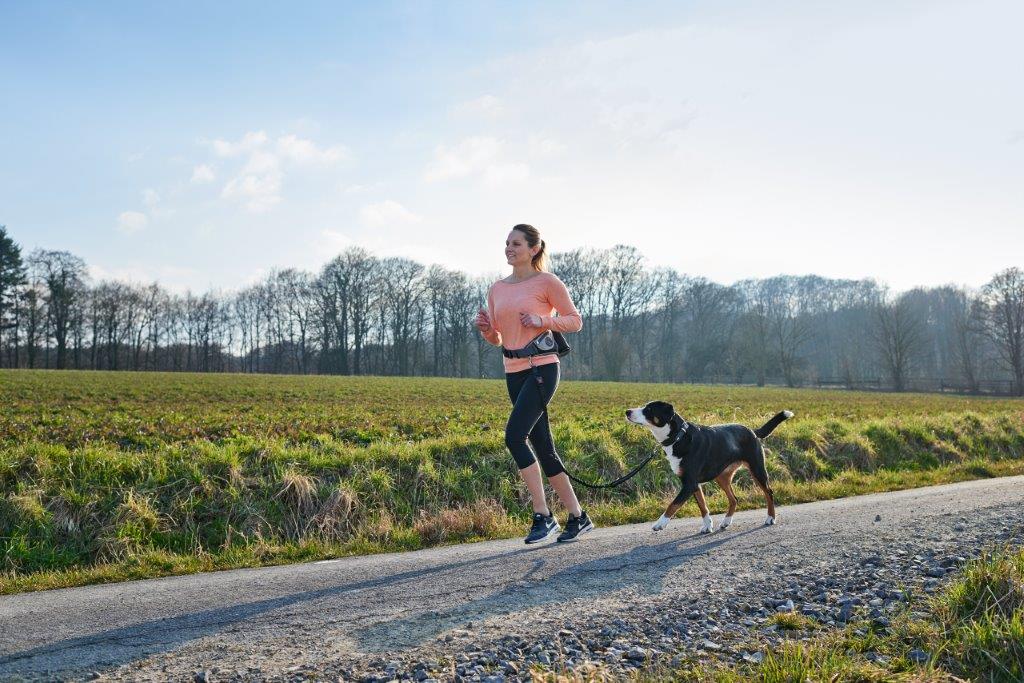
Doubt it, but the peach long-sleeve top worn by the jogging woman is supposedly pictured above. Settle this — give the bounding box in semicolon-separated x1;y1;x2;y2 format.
483;272;583;373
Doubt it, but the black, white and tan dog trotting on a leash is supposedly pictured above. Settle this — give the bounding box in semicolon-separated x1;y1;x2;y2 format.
626;400;793;533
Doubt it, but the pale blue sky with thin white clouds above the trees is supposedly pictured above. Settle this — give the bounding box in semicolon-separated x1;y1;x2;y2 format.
0;0;1024;291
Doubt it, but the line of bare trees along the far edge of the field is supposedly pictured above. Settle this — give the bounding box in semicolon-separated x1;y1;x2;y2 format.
0;226;1024;395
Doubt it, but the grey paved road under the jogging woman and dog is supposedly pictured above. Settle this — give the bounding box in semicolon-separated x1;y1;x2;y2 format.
0;477;1024;680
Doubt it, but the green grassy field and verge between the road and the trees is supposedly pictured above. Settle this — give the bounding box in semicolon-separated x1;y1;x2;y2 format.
0;371;1024;593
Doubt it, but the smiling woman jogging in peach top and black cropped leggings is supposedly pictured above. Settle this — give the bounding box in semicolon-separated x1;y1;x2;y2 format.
475;225;594;543
